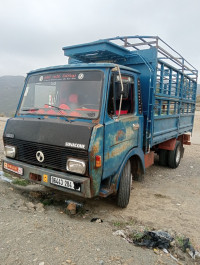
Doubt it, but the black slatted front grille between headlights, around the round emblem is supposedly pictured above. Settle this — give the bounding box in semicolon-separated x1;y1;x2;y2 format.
4;137;88;171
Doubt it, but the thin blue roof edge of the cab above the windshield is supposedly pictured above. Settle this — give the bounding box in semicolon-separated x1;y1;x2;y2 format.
28;63;140;74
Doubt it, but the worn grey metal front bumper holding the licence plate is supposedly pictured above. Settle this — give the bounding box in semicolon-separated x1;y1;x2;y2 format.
2;158;92;198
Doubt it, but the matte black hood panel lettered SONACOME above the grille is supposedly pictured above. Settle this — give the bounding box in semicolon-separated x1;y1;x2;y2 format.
4;118;95;150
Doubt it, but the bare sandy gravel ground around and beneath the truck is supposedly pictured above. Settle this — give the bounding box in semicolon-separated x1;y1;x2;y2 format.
0;112;200;265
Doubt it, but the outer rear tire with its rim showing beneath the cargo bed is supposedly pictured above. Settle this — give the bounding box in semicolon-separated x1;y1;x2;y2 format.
168;141;183;168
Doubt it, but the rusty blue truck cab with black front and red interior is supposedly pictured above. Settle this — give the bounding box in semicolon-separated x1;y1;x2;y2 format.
3;63;144;206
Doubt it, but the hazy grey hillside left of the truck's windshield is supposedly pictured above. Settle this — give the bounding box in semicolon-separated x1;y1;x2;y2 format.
0;76;24;117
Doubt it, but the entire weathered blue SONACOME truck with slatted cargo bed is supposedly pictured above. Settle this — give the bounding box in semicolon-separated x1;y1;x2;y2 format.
2;36;198;208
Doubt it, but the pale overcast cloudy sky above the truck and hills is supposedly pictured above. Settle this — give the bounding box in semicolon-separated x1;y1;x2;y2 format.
0;0;200;76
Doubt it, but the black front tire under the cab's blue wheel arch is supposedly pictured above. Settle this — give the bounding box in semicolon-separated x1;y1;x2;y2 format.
117;160;132;208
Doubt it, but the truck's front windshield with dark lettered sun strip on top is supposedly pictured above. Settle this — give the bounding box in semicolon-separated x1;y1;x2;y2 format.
19;71;103;119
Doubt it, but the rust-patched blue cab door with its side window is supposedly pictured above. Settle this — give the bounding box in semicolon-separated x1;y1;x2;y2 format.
103;73;139;179
